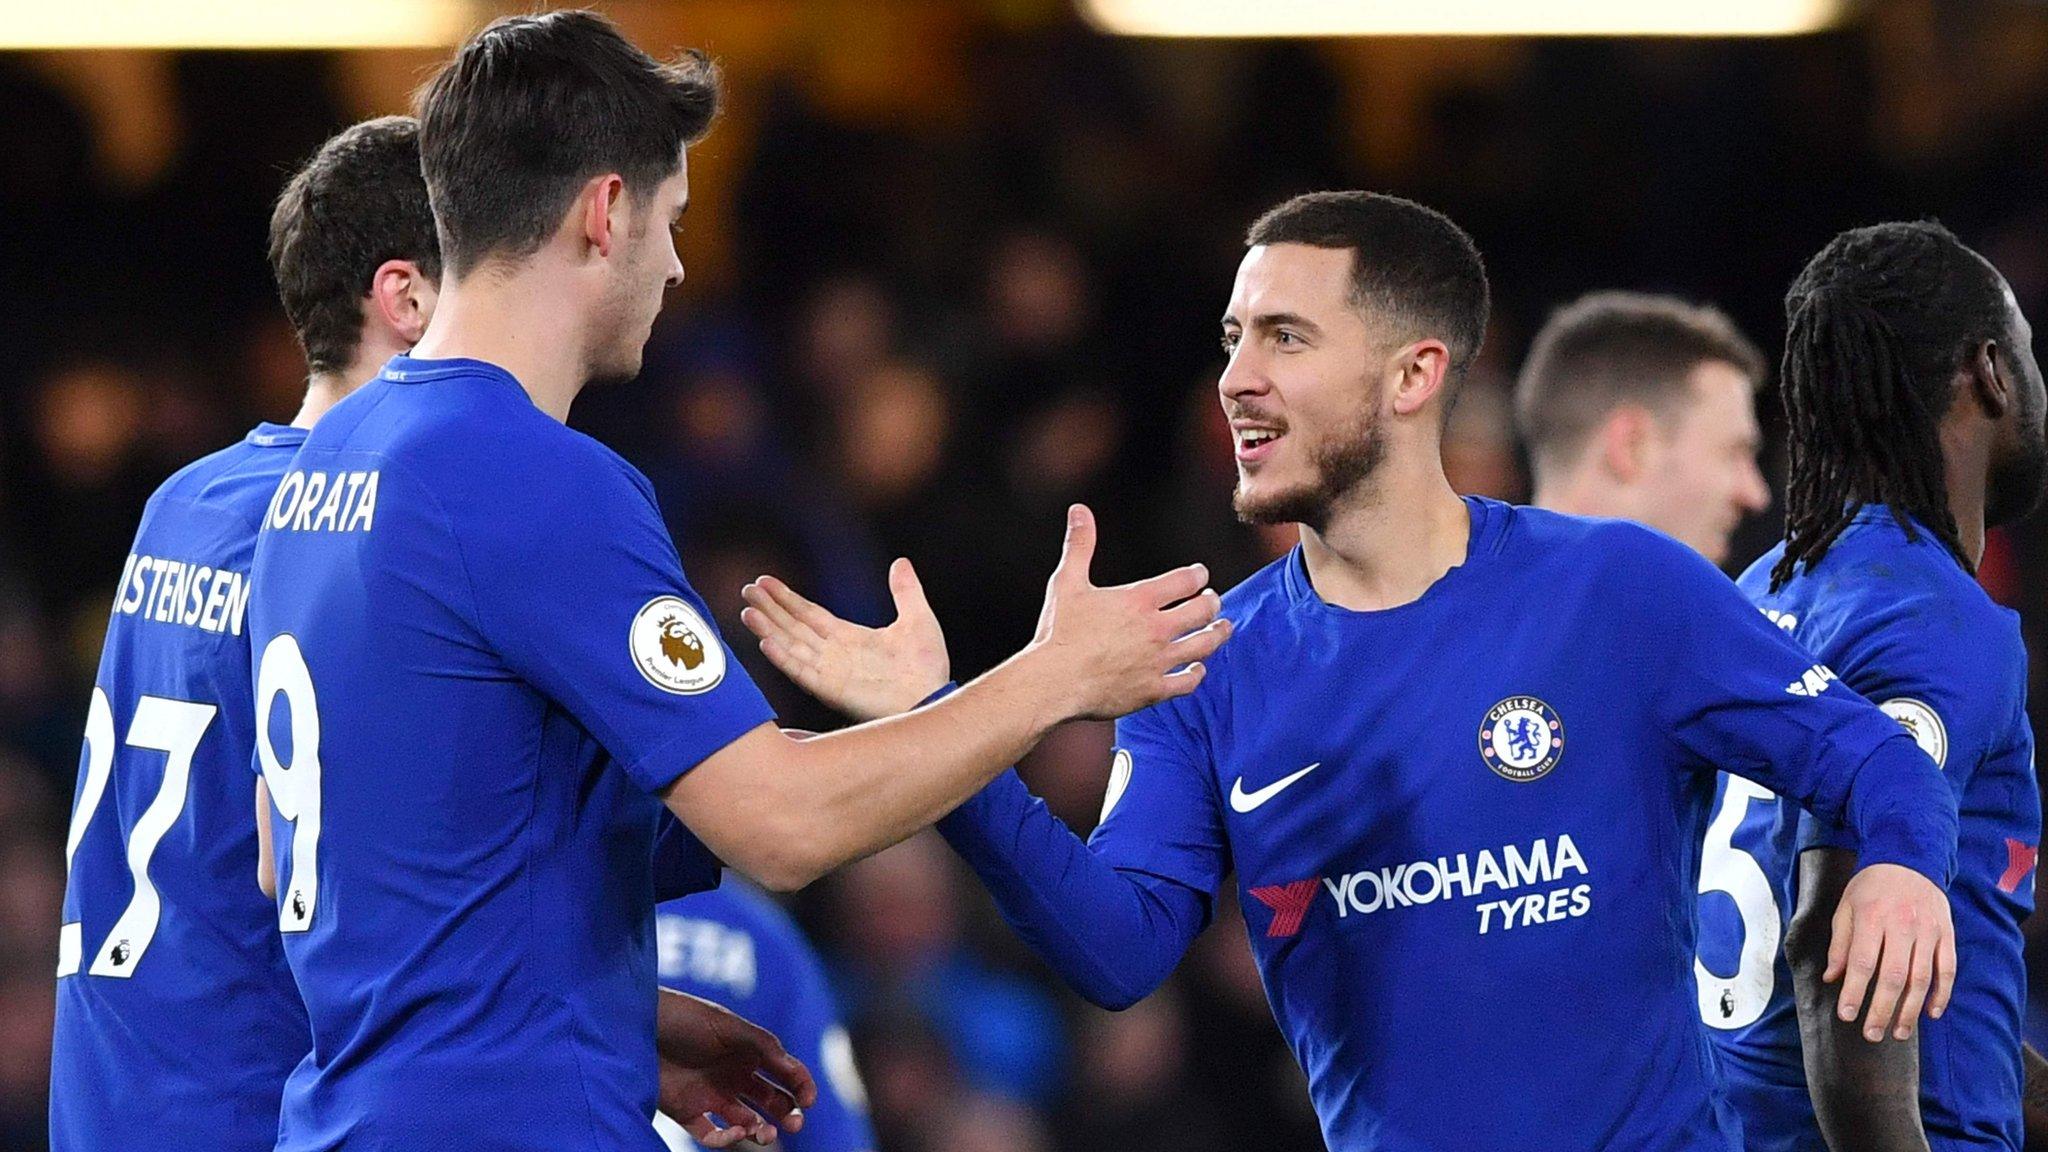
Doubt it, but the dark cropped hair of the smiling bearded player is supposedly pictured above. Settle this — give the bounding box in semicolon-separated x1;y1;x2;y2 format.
1245;193;1489;383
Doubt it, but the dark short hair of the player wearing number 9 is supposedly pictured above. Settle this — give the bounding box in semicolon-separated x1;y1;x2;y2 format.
420;10;719;275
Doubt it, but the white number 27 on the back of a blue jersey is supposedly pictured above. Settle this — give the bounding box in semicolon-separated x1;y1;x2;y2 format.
57;689;219;980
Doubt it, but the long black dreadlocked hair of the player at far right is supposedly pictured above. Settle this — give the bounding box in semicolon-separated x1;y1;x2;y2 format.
1772;221;2007;592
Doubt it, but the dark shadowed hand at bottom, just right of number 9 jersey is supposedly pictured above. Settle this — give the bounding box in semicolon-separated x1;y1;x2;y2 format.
655;988;817;1148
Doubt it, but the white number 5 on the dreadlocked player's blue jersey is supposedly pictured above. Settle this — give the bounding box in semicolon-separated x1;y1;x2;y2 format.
1692;775;1784;1031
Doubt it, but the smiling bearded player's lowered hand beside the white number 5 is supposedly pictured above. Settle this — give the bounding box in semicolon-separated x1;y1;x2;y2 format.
1821;863;1956;1041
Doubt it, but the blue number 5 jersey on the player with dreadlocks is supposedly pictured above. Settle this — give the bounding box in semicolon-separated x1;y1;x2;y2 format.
1700;508;2042;1152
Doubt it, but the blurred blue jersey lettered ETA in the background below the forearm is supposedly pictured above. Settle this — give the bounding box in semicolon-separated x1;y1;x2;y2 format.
655;875;874;1152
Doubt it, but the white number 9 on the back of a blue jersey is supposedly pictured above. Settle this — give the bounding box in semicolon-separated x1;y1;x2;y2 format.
256;631;319;933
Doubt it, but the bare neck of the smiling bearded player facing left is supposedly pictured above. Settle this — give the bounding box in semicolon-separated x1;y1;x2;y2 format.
1300;461;1473;611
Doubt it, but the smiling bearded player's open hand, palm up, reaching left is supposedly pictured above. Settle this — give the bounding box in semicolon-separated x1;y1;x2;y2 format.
739;560;950;719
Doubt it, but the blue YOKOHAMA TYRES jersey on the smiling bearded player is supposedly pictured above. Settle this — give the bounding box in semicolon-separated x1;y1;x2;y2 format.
1069;498;1956;1152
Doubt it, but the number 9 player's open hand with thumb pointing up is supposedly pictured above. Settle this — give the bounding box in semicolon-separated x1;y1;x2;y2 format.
1026;504;1231;719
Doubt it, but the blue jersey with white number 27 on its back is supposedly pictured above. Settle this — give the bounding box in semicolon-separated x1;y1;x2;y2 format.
49;424;309;1152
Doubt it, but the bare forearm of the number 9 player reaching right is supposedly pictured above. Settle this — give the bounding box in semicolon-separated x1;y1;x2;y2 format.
670;650;1075;892
